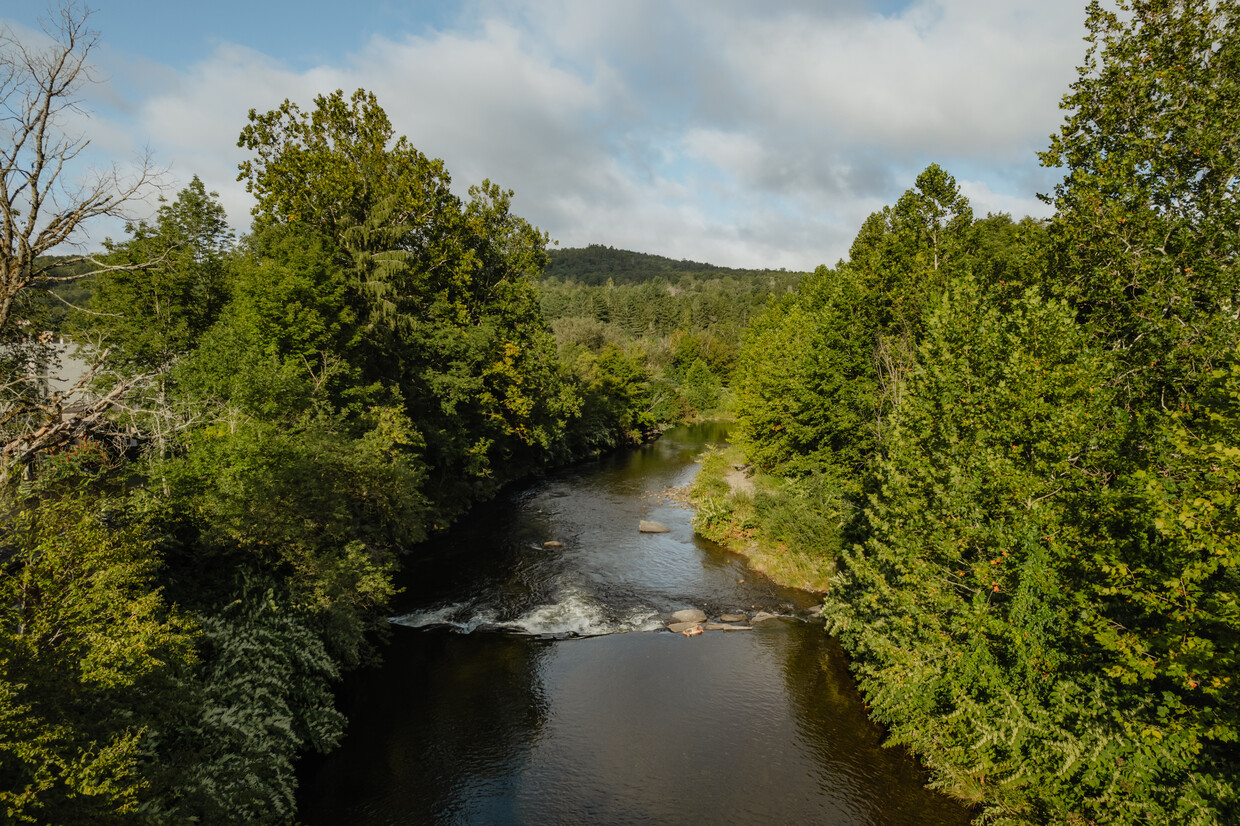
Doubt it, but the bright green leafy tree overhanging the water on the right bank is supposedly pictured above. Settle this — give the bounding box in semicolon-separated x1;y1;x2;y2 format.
825;280;1135;820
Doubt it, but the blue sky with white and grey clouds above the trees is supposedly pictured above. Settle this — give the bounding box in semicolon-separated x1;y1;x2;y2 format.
0;0;1085;269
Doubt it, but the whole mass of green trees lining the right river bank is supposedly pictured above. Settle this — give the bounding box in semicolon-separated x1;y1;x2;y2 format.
699;0;1240;825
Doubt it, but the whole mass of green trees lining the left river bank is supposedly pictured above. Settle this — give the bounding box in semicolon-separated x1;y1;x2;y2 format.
0;57;743;824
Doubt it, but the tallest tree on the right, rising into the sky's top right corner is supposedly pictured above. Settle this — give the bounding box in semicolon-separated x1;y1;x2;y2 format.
1042;0;1240;407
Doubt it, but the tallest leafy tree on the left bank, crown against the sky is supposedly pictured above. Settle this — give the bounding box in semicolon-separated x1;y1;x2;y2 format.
238;89;575;508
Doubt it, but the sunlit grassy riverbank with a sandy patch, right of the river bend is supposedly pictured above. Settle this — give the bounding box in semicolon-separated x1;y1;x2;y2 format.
686;445;842;594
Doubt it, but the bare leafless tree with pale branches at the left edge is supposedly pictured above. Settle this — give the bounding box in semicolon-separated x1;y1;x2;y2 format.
0;2;156;480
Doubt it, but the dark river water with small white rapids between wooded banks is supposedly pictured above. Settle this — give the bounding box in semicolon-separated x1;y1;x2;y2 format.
301;424;968;826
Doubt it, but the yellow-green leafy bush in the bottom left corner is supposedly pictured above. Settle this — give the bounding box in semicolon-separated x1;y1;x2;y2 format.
0;490;193;824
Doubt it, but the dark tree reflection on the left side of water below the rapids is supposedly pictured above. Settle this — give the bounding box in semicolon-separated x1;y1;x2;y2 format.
301;634;548;824
